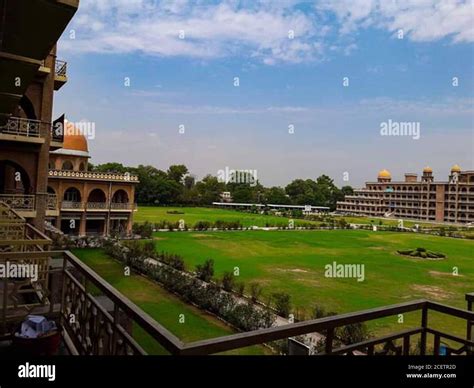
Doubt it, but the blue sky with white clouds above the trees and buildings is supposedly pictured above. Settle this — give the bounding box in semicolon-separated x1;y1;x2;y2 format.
54;0;474;187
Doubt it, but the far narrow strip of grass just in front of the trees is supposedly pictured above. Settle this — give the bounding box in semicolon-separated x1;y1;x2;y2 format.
134;206;448;227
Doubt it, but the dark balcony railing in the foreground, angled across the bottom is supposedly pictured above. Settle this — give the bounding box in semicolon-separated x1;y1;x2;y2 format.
0;252;474;355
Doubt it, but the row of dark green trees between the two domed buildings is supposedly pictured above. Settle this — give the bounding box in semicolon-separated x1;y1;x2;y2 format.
89;163;353;210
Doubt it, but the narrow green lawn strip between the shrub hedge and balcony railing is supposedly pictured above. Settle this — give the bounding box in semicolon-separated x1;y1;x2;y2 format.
74;249;268;354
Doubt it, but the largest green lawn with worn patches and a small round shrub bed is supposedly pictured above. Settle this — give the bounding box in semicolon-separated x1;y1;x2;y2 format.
155;230;474;335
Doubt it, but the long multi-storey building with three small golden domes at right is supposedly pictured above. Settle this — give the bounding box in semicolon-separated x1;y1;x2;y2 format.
337;164;474;223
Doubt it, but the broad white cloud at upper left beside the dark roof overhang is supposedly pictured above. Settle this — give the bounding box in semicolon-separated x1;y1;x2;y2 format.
62;0;326;64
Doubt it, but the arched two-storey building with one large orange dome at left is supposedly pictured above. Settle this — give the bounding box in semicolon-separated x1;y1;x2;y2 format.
46;122;138;236
